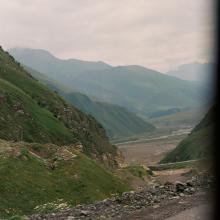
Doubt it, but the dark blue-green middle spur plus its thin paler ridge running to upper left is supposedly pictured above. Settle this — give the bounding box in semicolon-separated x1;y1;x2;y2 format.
25;66;155;139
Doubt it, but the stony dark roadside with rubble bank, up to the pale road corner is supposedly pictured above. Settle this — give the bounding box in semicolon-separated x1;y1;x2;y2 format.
28;175;213;220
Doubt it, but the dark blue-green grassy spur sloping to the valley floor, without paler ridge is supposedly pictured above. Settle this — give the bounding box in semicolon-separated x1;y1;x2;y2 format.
64;93;155;139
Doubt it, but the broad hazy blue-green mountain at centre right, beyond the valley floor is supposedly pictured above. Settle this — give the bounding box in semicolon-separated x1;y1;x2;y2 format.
72;66;211;114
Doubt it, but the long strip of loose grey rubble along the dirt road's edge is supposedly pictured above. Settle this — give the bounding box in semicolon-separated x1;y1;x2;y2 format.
27;176;211;220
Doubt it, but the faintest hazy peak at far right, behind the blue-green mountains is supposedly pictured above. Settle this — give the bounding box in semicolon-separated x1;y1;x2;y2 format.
167;62;216;85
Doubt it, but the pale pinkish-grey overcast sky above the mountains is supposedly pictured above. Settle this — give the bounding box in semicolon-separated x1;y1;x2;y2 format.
0;0;214;72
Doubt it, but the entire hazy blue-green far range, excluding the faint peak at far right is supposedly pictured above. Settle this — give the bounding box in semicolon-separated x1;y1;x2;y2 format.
9;48;211;117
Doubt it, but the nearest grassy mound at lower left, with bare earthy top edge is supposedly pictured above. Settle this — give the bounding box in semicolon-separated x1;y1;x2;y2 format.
0;140;129;217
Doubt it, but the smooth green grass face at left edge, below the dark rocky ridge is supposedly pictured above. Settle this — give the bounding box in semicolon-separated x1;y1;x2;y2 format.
0;79;76;144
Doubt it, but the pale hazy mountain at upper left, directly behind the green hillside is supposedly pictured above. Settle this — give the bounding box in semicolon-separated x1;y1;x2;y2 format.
9;48;111;82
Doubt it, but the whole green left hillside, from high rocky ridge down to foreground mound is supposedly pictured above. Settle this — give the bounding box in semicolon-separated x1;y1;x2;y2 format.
0;47;131;219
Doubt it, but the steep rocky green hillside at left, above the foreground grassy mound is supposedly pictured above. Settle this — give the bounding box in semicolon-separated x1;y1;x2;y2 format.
0;46;117;165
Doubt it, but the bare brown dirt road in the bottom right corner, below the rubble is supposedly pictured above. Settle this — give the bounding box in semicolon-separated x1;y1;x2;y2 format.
120;192;213;220
